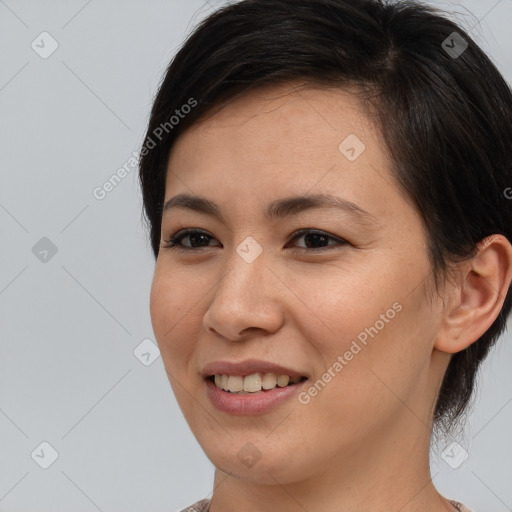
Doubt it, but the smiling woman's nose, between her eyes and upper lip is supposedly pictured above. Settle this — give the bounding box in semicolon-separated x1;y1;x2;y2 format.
203;253;284;341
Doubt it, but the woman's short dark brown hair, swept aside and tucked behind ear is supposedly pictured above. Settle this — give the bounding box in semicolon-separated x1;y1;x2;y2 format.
140;0;512;431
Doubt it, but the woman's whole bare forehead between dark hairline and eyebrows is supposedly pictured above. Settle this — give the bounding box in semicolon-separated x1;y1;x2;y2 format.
165;84;398;224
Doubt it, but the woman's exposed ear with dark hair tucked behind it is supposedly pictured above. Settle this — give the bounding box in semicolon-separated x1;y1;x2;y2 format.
434;235;512;353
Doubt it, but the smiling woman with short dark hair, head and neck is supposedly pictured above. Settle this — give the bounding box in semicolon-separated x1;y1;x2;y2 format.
140;0;512;512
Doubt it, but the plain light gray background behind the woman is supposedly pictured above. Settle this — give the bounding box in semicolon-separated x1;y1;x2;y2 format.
0;0;512;512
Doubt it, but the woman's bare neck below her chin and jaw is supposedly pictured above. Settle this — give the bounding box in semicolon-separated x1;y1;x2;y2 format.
210;411;456;512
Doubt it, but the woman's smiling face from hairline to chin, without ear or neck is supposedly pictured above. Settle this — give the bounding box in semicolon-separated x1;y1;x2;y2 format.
151;85;448;484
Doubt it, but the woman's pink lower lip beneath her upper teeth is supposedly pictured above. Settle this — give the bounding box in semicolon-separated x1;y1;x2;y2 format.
205;379;307;415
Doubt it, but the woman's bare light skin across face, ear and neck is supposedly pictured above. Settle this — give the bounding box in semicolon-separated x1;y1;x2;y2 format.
150;84;512;512
